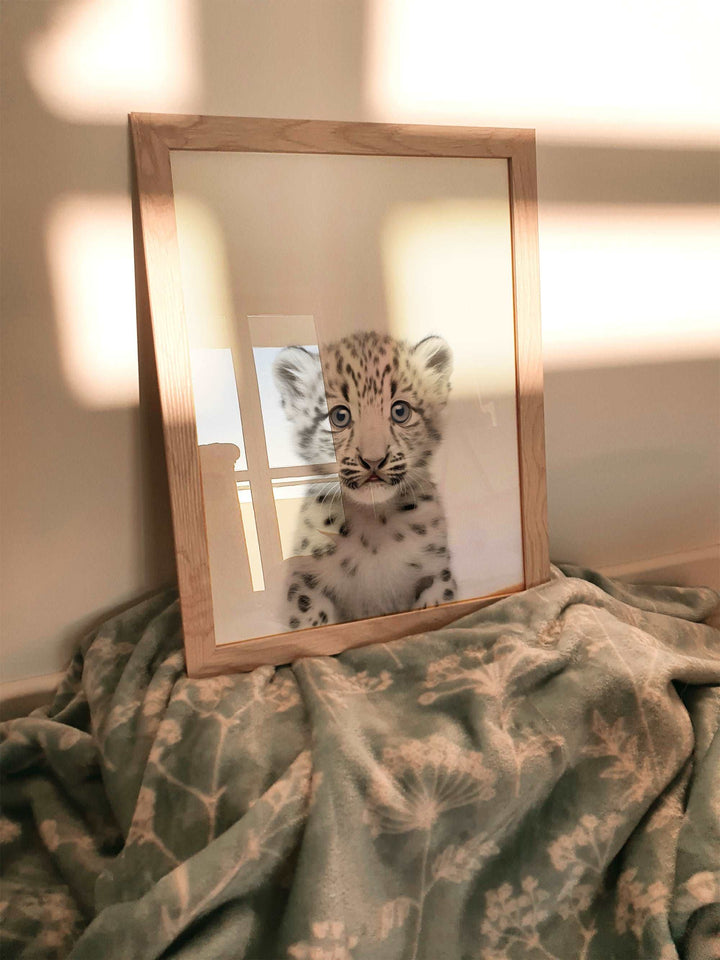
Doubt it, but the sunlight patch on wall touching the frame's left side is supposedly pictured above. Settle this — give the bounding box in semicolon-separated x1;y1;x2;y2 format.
46;195;138;408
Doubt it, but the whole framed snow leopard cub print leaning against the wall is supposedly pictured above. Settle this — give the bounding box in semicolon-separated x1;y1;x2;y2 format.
130;114;549;676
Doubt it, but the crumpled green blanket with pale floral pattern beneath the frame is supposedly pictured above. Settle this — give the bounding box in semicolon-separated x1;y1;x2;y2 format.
0;568;720;960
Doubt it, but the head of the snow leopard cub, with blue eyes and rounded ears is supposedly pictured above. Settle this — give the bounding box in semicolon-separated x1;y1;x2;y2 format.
274;333;452;504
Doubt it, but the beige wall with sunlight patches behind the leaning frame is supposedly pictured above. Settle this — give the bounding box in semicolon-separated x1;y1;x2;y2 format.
0;0;720;681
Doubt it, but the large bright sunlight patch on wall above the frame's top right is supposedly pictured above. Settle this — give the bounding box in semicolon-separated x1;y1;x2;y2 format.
365;0;720;143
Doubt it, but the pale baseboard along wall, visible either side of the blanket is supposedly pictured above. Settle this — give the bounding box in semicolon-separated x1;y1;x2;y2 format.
0;543;720;720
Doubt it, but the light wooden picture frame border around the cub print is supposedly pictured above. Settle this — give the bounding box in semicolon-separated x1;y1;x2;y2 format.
130;114;550;676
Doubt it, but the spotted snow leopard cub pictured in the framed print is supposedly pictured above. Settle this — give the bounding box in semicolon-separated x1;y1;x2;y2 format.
273;332;456;629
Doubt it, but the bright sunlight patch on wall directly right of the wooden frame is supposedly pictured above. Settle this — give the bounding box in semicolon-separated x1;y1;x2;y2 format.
540;204;720;368
